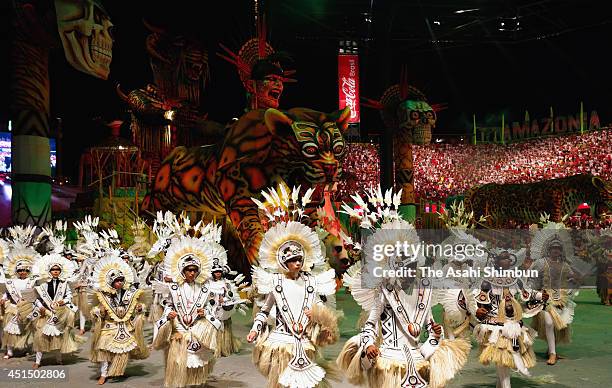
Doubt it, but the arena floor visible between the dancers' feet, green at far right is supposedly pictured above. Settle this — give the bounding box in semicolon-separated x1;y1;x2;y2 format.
0;289;612;388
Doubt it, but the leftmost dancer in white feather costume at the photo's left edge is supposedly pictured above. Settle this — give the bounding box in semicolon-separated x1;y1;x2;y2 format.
0;244;40;359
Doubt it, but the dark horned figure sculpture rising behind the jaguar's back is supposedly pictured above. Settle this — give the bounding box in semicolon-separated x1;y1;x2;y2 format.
117;21;223;165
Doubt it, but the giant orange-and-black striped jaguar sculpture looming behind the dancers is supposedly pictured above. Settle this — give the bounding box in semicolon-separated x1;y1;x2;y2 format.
143;108;350;267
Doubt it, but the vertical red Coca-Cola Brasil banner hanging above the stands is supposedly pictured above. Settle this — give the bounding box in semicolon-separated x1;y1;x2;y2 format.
338;54;359;123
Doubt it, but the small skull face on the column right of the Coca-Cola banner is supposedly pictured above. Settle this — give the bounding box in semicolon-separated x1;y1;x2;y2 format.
397;100;436;144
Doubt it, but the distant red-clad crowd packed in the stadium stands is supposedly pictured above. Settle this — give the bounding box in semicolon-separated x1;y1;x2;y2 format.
338;129;612;200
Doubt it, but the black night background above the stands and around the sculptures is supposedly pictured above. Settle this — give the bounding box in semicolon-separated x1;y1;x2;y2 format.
2;0;612;179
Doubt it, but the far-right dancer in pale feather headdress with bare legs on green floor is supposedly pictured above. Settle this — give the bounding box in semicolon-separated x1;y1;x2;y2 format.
530;222;579;365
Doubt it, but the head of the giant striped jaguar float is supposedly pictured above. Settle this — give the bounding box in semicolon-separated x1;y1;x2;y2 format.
265;108;350;184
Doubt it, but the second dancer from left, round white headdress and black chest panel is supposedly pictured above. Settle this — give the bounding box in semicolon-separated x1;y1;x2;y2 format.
32;253;84;368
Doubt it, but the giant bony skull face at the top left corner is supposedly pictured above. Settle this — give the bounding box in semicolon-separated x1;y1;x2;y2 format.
55;0;113;79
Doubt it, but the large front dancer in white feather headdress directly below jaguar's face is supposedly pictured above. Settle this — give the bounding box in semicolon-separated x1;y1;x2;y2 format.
247;185;339;388
